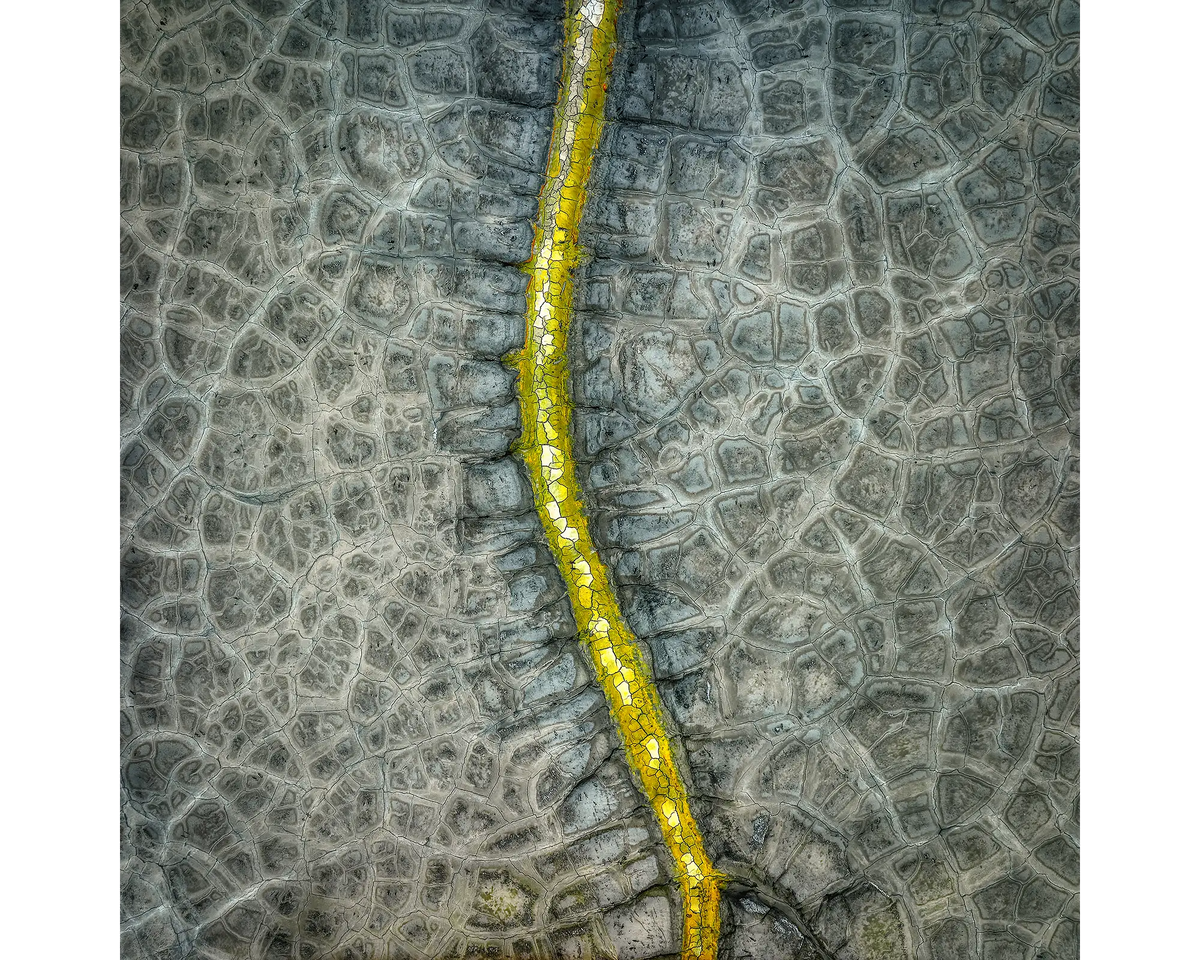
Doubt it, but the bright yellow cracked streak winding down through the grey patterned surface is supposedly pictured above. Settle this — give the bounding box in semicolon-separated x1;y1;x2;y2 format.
512;0;725;960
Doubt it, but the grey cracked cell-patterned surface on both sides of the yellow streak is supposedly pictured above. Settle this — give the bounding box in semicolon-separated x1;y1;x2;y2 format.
118;0;1082;960
